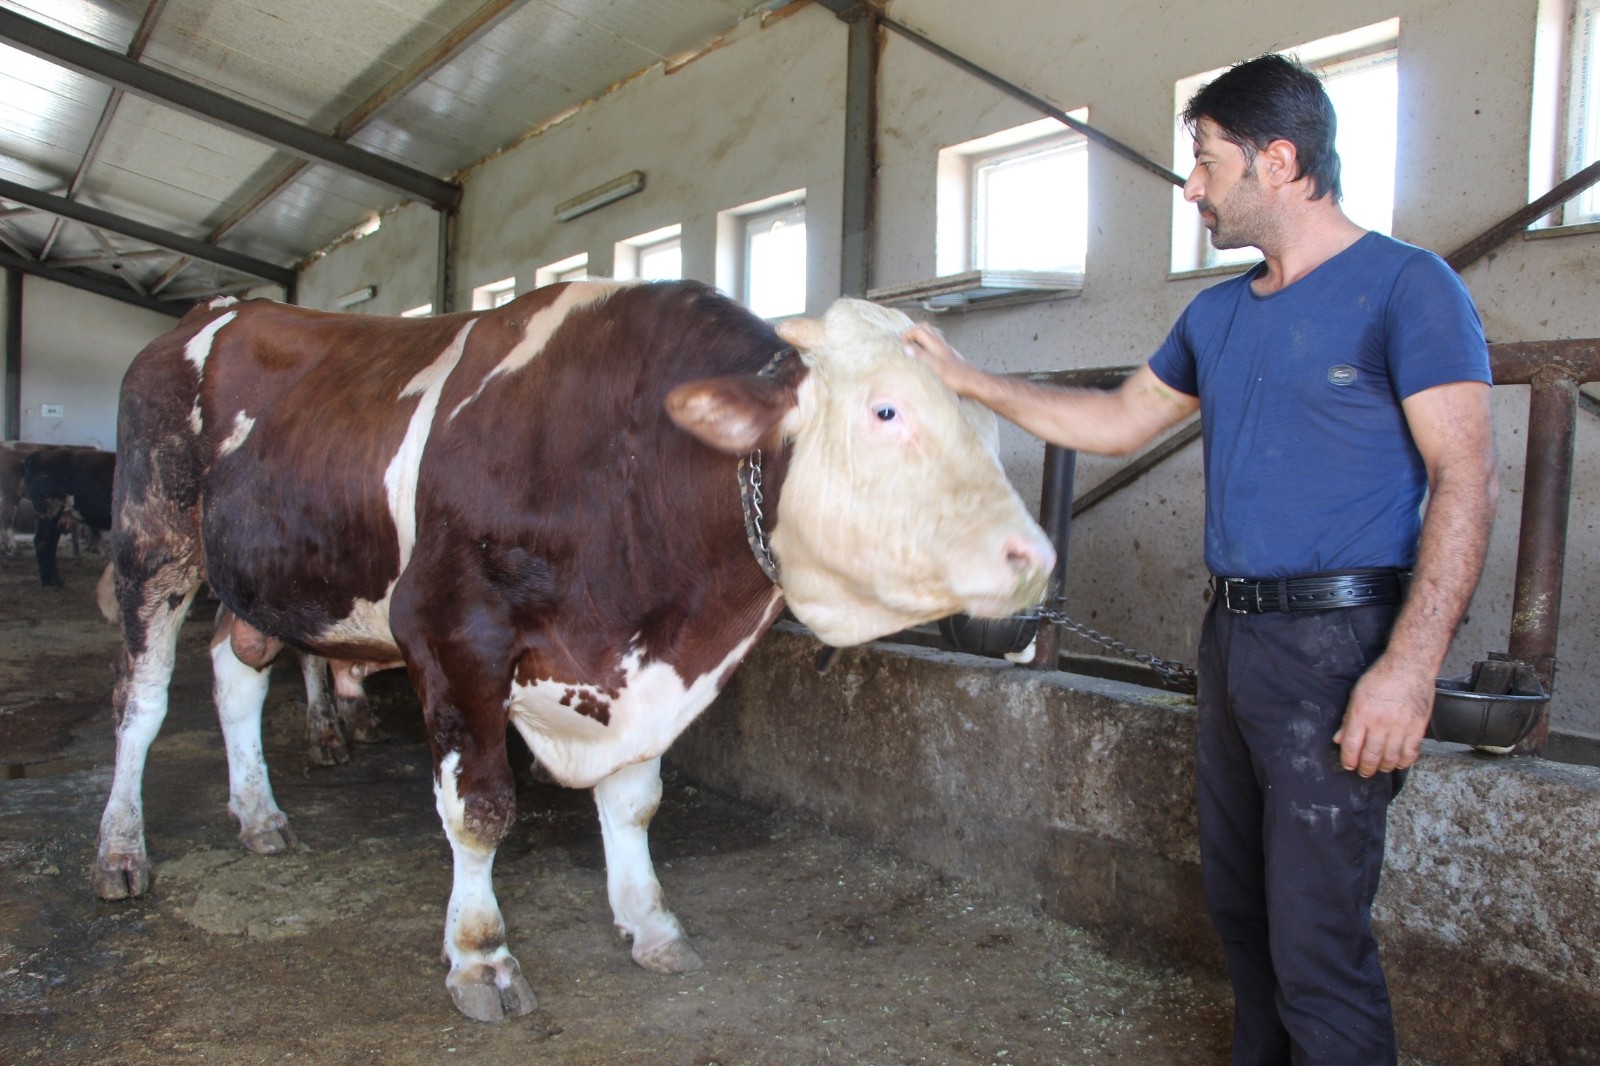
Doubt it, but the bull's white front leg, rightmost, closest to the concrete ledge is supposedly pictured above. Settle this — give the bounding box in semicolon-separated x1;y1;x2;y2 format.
594;759;706;973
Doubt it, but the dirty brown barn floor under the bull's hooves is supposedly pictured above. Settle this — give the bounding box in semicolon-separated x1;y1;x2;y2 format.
0;546;1411;1066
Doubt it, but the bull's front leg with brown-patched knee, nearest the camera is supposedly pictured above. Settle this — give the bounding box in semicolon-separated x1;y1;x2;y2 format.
430;742;539;1021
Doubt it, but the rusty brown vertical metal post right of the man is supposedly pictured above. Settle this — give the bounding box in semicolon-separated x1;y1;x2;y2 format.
1509;367;1578;755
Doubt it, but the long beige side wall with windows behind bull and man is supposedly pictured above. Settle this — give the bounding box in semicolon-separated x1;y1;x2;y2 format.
291;0;1600;738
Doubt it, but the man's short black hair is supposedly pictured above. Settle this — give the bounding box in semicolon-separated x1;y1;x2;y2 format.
1184;53;1344;203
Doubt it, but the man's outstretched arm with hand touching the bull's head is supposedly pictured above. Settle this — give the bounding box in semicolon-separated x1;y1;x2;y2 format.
902;325;1200;455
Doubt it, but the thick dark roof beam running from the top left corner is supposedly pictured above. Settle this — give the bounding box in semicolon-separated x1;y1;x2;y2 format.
0;8;461;210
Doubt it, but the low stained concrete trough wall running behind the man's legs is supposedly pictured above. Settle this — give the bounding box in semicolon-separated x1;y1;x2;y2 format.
669;627;1600;1064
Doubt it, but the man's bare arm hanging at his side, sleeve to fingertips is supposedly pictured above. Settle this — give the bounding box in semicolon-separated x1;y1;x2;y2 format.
1333;381;1499;778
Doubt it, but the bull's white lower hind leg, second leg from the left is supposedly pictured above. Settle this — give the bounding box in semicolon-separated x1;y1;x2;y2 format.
211;611;294;855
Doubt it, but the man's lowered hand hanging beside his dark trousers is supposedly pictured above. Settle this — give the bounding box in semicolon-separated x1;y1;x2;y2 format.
1333;655;1435;778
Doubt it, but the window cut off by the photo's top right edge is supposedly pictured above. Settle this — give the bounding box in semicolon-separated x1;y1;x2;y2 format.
1528;0;1600;226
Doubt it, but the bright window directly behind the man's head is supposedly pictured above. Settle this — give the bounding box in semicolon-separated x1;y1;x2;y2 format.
1173;19;1400;272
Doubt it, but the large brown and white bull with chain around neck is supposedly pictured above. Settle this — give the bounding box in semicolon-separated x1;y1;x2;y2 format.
94;282;1054;1021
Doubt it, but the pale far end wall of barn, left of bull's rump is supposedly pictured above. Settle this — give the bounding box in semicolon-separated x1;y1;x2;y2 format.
11;277;178;451
